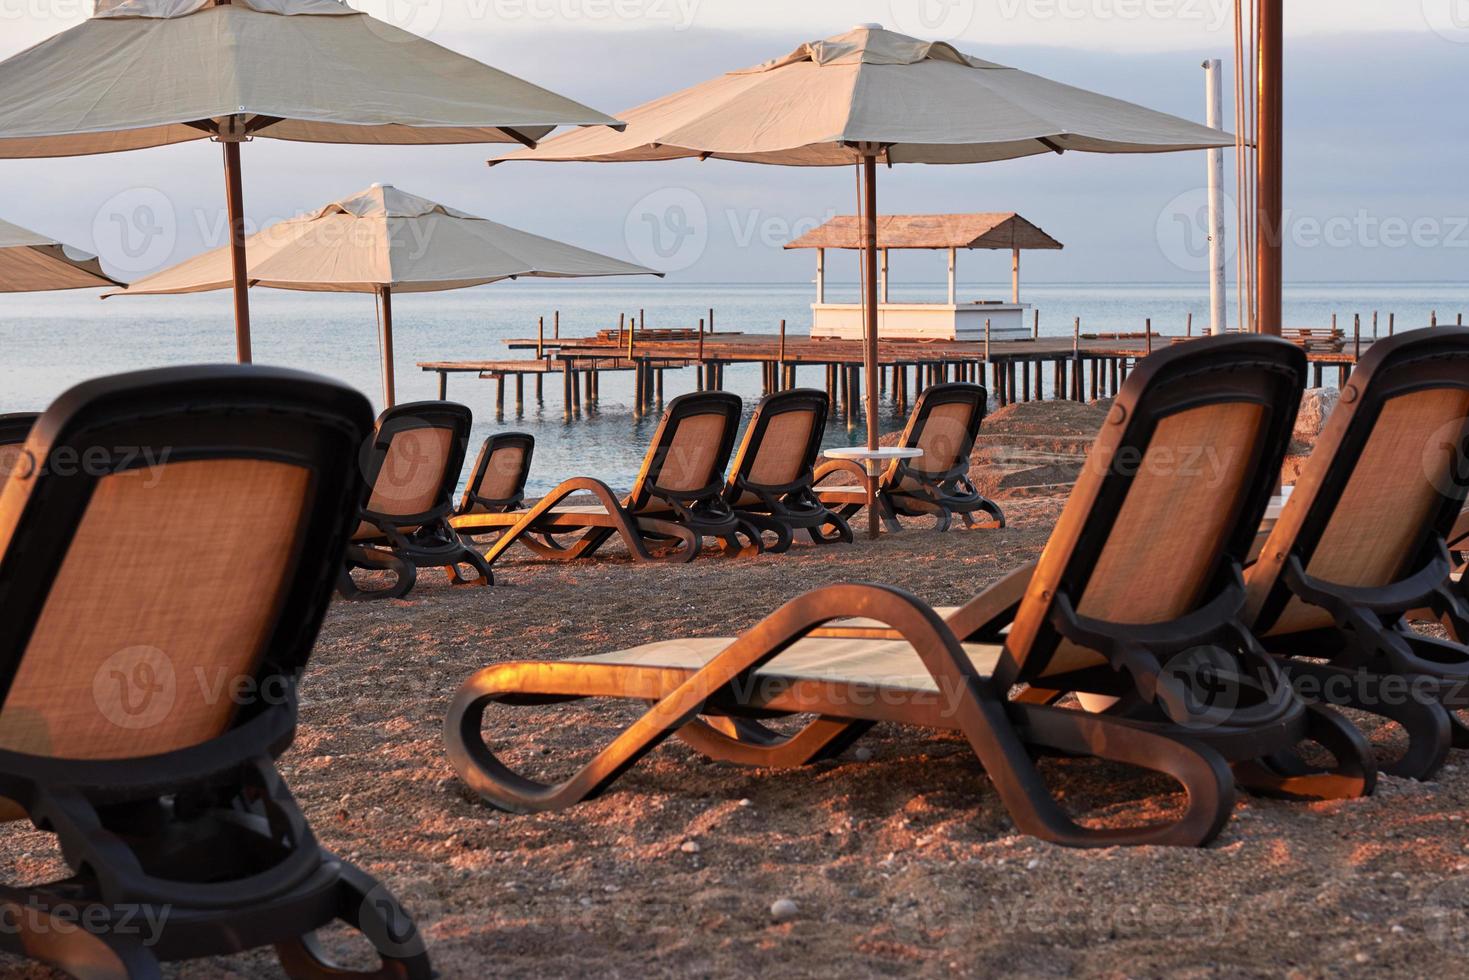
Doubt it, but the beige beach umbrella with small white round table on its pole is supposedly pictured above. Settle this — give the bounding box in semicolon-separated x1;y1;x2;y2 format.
505;25;1234;536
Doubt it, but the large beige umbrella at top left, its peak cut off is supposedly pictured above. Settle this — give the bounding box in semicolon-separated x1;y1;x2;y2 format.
0;0;616;361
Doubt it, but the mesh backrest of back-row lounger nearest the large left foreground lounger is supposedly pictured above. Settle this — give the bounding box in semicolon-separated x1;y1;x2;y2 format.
361;401;473;526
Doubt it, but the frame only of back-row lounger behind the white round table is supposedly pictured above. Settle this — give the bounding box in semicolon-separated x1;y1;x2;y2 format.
815;382;1005;532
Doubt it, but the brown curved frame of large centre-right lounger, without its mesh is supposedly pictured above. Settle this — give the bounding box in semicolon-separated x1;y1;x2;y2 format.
445;338;1375;846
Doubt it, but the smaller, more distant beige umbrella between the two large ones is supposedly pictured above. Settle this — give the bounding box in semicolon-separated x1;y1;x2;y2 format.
107;184;661;407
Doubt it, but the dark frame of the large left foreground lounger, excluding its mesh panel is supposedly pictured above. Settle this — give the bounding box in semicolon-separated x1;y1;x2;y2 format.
0;366;432;980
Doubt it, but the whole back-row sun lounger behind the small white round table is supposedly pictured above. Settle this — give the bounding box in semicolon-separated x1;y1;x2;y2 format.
817;382;1005;530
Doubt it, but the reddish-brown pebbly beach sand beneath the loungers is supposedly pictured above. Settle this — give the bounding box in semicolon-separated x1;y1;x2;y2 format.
0;403;1469;977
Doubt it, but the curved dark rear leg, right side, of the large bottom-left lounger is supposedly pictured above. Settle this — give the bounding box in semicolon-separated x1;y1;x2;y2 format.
276;864;433;980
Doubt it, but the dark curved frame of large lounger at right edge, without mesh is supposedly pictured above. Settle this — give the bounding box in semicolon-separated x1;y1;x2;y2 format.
1249;326;1469;779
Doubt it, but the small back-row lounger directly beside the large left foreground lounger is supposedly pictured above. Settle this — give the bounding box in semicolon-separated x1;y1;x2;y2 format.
338;401;495;599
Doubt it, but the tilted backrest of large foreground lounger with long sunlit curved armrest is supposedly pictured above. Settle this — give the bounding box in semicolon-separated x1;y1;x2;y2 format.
1002;336;1306;690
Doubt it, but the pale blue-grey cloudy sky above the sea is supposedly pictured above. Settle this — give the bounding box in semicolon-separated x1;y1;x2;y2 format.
0;0;1469;281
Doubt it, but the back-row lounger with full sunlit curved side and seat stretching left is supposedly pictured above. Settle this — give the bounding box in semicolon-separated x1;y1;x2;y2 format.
451;391;762;564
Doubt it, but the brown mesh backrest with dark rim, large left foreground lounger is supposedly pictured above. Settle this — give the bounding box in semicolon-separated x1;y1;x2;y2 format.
0;366;372;776
